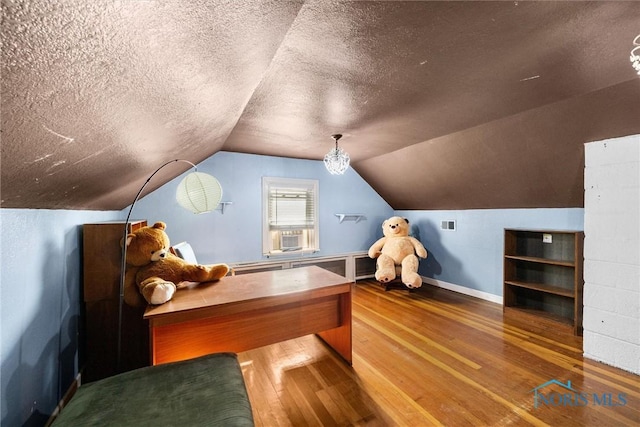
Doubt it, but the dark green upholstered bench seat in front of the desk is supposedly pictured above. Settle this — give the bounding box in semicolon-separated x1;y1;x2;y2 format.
53;353;254;427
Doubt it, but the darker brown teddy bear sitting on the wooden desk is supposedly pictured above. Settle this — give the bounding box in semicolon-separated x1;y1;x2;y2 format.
120;222;229;307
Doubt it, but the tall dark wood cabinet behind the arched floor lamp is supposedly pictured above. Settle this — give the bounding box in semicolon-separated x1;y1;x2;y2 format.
82;221;149;382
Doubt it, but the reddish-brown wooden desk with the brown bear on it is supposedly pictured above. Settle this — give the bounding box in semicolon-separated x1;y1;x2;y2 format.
144;266;351;365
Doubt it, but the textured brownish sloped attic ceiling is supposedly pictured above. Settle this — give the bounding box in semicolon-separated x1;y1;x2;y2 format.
0;0;640;210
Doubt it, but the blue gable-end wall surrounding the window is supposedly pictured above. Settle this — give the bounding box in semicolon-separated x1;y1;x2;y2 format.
132;152;393;263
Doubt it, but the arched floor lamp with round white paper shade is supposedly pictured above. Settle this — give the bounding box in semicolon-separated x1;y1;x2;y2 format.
116;159;222;373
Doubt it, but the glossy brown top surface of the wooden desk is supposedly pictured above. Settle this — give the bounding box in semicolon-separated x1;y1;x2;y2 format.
144;266;351;319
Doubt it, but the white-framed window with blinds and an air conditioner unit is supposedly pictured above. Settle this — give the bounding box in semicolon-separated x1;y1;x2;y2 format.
262;177;319;255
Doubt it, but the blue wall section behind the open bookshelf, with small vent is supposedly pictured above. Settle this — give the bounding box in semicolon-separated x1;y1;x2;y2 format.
396;208;584;296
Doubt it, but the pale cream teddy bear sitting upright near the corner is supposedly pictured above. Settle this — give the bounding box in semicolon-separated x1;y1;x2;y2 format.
369;216;427;289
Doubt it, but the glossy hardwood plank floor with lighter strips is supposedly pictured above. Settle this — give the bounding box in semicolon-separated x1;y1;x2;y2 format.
239;281;640;426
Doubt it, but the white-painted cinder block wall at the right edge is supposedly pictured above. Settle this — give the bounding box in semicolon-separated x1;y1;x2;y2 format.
583;135;640;374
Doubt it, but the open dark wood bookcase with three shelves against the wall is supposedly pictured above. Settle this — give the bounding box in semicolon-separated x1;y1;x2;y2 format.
504;229;584;335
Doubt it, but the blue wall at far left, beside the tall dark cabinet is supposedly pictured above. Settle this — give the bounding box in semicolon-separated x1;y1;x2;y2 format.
0;209;121;427
